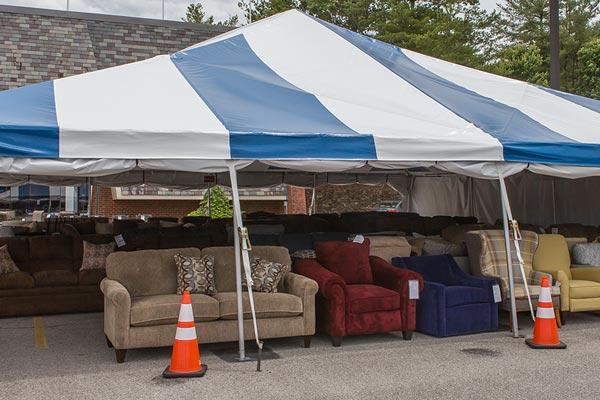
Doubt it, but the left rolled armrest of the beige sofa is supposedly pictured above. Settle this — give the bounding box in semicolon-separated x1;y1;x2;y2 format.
100;278;131;349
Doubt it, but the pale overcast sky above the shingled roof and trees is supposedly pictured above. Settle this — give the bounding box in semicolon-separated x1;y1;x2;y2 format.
0;0;503;21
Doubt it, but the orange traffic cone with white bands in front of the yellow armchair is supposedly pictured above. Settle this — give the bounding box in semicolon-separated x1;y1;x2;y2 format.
525;277;567;349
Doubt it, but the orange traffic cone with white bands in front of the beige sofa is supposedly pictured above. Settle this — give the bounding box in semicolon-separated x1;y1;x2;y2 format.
163;290;207;378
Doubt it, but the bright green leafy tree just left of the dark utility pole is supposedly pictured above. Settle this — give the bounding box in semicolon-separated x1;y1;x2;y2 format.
492;44;549;86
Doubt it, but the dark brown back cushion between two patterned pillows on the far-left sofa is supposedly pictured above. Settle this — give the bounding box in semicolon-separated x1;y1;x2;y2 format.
29;235;75;272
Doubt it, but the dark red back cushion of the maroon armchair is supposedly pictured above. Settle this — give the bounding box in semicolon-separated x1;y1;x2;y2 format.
315;239;373;285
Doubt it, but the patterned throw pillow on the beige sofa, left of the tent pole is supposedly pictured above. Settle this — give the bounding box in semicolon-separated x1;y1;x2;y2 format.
175;254;217;296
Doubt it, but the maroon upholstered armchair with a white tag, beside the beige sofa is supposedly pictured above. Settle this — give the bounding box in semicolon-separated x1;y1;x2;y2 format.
294;240;423;347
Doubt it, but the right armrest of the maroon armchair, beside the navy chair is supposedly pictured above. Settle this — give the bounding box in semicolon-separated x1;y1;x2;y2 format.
369;256;423;331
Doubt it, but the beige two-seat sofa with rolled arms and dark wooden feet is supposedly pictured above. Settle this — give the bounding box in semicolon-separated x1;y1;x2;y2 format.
100;246;318;362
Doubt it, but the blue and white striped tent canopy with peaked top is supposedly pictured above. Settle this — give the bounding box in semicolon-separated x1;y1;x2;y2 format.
0;10;600;183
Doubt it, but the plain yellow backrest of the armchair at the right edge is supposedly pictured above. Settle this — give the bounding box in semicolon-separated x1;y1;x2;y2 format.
533;234;571;279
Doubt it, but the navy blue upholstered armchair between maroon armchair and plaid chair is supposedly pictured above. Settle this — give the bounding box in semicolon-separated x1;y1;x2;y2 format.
392;255;498;337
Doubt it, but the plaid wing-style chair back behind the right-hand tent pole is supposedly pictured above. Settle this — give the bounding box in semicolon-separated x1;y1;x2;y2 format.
465;230;539;298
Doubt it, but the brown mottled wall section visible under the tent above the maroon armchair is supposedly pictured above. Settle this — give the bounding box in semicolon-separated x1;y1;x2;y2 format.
306;184;400;213
